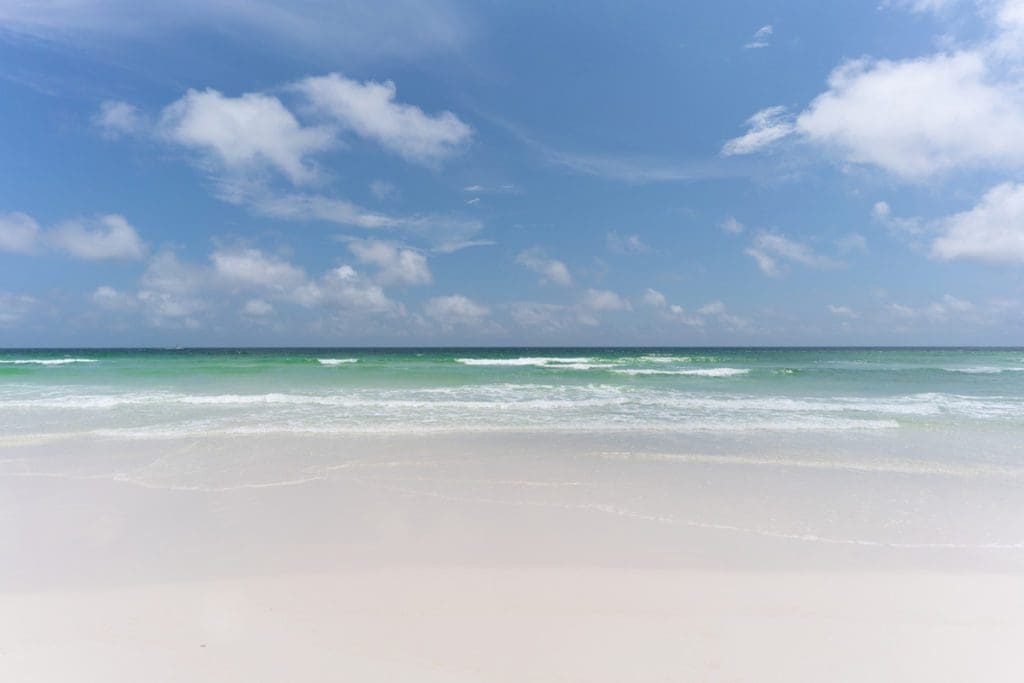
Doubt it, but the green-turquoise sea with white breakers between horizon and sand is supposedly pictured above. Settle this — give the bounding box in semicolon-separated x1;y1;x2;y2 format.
0;348;1024;440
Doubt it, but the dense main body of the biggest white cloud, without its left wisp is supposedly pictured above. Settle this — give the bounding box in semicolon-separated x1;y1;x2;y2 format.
797;51;1024;180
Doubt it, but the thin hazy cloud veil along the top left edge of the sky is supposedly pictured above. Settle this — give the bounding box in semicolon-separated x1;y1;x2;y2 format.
0;0;472;60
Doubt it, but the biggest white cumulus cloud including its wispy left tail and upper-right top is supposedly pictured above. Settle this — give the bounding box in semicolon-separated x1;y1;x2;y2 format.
723;0;1024;182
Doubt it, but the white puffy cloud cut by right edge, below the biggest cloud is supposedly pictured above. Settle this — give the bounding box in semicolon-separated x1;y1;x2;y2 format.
932;182;1024;263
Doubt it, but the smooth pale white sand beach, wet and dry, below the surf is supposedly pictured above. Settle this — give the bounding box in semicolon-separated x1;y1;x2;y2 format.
0;436;1024;683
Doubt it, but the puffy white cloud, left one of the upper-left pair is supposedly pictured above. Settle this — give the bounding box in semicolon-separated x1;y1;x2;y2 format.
160;89;334;183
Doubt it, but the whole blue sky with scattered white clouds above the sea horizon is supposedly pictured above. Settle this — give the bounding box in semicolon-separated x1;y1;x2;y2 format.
0;0;1024;347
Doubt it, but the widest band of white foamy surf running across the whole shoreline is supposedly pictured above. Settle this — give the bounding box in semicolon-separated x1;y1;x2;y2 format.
0;387;1024;423
